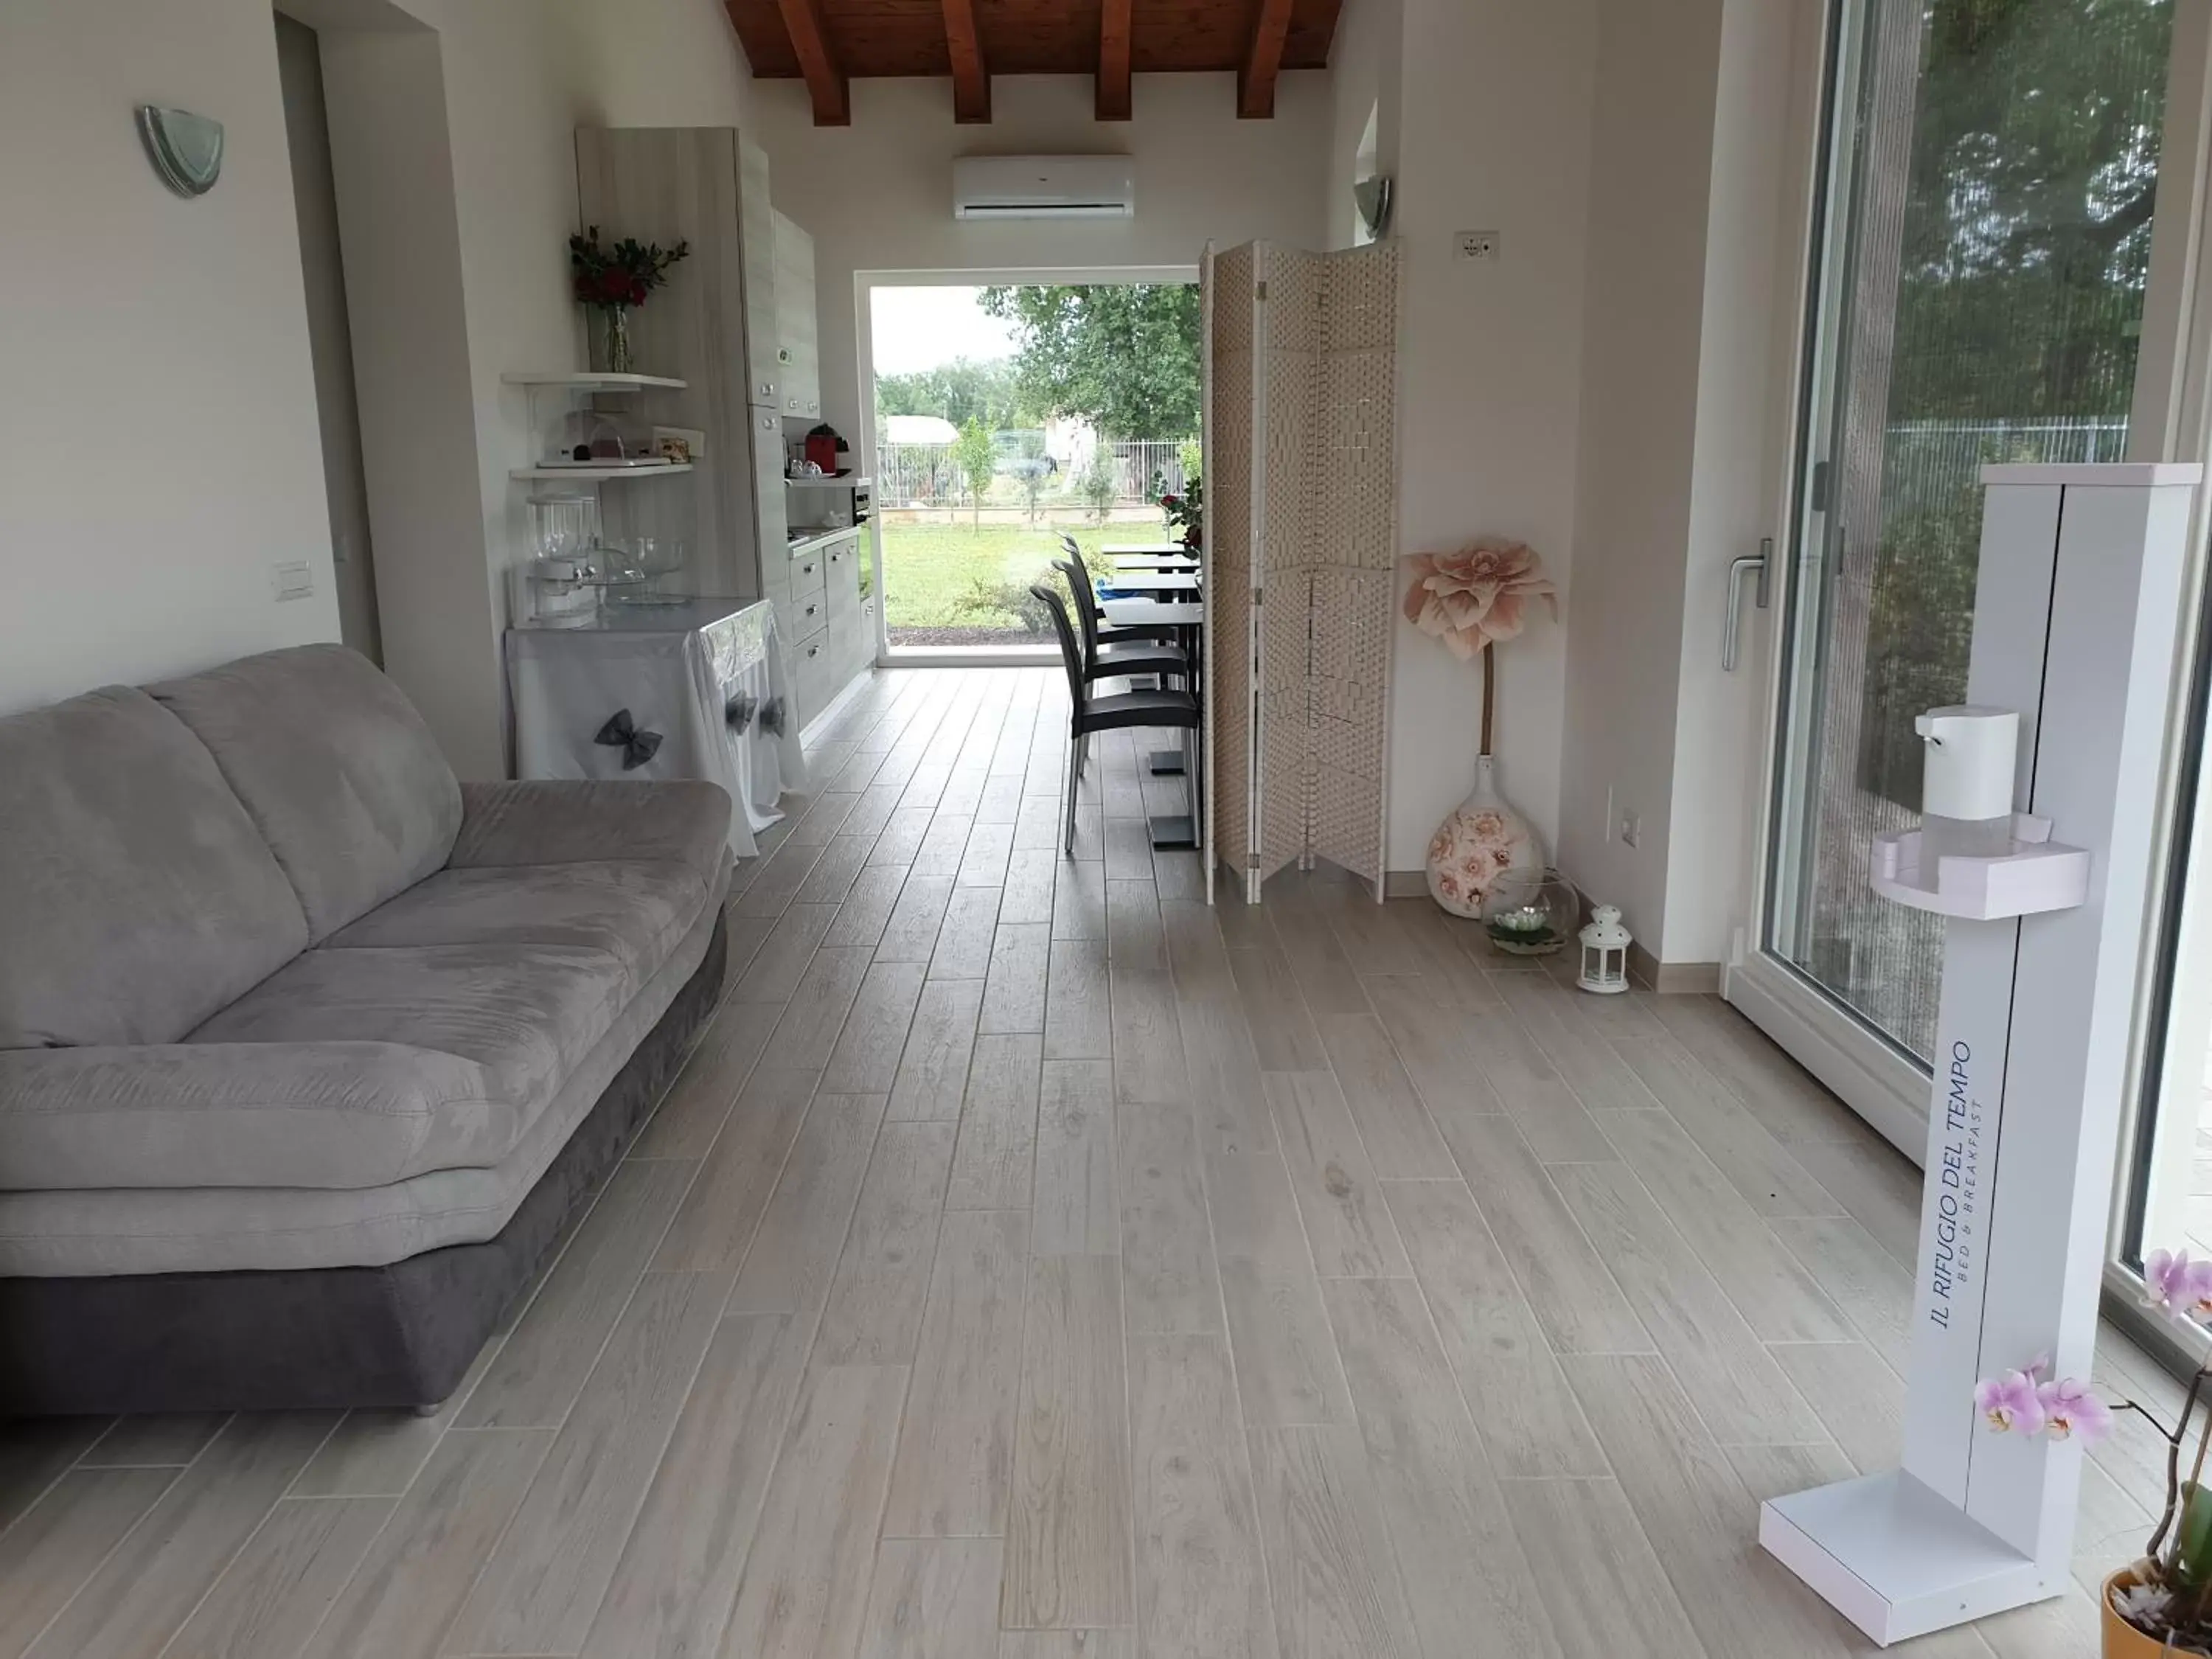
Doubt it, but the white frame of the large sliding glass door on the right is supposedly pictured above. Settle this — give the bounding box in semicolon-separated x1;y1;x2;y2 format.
1723;0;2212;1186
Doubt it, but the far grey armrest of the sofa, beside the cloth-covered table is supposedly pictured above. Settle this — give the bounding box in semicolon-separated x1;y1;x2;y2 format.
447;779;730;887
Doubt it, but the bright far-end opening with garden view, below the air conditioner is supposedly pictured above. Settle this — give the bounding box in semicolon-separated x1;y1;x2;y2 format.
867;279;1201;659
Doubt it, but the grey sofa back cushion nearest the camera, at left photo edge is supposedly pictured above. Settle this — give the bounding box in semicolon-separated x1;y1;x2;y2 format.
0;686;307;1048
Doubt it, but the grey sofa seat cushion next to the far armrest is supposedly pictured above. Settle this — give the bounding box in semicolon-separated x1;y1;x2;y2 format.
323;860;708;991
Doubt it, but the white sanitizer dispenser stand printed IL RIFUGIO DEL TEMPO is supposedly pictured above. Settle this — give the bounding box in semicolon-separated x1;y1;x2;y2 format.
1759;465;2201;1646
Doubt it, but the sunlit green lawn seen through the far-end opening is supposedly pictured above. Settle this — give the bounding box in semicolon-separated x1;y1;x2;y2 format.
883;524;1152;646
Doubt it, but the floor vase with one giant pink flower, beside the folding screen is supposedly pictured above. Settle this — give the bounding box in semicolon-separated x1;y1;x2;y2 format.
1405;538;1559;920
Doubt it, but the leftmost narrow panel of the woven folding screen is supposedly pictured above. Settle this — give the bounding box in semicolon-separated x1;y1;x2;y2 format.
1206;243;1256;869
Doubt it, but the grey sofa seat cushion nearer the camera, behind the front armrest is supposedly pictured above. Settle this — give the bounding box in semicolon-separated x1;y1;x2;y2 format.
188;945;630;1119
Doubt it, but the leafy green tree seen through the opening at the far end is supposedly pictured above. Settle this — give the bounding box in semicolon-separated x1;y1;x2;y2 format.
982;283;1201;438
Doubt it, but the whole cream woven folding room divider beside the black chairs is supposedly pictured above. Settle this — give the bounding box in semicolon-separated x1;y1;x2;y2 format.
1203;241;1398;900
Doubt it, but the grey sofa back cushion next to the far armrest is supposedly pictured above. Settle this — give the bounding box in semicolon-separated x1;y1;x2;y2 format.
148;646;460;940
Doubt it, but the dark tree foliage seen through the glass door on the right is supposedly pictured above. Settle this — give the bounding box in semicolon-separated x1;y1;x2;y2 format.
1854;0;2174;807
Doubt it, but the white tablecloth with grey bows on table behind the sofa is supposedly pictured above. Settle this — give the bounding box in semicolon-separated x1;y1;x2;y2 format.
507;599;807;858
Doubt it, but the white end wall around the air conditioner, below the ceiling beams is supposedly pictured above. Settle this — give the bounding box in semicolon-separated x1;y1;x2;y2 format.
752;71;1329;442
